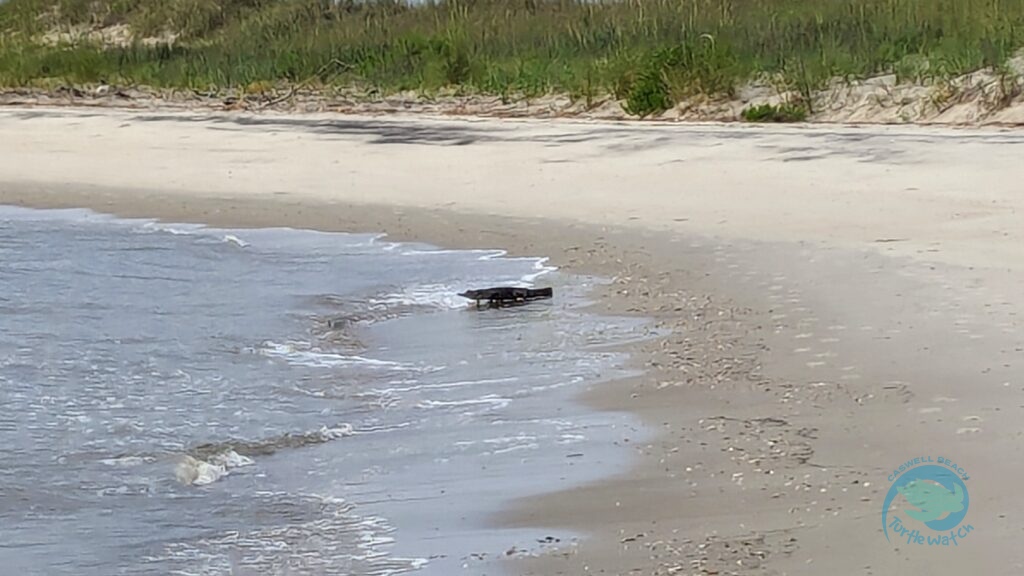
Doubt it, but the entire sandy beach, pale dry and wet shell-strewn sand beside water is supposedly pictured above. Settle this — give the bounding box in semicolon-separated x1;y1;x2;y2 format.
0;108;1024;575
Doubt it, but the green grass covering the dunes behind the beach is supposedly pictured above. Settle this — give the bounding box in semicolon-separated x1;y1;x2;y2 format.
0;0;1024;115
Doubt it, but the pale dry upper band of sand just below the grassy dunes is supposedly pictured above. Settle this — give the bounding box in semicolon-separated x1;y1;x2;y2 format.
0;110;1024;265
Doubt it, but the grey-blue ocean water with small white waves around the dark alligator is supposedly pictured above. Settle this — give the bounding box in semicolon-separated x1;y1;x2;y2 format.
0;208;649;576
